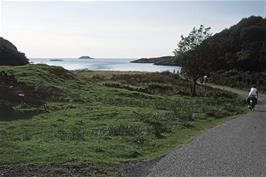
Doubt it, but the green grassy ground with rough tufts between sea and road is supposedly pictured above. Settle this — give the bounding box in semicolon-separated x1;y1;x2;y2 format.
0;65;245;176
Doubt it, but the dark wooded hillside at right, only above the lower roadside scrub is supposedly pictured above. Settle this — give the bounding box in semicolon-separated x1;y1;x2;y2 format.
192;16;266;72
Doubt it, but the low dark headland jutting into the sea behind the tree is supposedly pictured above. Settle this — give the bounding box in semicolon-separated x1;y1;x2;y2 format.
131;56;178;65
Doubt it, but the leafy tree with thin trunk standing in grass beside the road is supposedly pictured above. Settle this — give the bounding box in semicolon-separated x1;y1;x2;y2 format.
173;25;212;96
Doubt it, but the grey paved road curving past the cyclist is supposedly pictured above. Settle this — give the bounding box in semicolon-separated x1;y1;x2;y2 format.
147;87;266;177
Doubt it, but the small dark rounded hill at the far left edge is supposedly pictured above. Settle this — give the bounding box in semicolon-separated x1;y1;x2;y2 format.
0;37;29;65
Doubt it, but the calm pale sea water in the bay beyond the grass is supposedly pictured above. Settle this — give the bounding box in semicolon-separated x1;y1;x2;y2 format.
30;58;180;72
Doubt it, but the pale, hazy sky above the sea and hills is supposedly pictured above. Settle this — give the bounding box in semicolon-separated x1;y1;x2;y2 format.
0;0;265;58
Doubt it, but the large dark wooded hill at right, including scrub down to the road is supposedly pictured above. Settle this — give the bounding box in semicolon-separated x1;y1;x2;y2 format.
187;16;266;93
